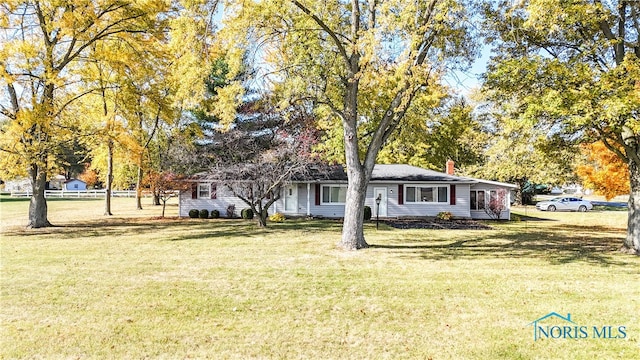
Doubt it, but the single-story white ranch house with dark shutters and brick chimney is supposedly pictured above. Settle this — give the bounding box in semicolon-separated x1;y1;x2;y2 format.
179;162;517;219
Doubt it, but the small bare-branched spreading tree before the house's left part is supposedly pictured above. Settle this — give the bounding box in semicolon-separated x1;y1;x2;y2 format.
192;58;317;227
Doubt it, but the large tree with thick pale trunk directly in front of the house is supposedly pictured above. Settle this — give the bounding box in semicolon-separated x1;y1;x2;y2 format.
225;0;473;250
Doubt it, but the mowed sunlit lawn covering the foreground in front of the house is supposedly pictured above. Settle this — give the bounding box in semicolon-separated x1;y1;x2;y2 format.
0;199;640;359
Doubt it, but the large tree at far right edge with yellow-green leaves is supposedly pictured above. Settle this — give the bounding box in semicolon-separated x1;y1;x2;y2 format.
485;0;640;255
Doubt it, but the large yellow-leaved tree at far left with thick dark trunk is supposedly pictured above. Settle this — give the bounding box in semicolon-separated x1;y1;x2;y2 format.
0;0;166;228
